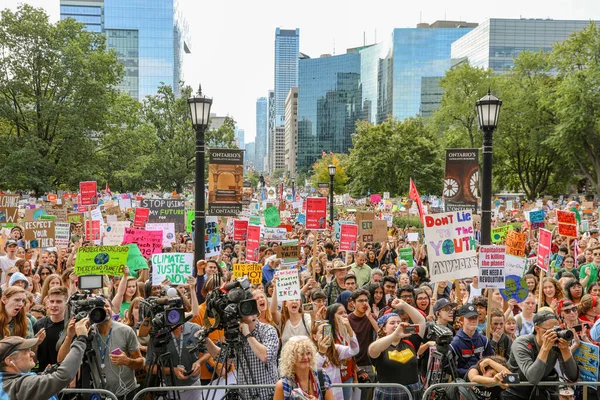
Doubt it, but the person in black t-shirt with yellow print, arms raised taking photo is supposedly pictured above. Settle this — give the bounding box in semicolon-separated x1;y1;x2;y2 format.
369;299;425;400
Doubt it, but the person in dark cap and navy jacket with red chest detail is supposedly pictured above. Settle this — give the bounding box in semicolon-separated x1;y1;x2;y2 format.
450;303;494;378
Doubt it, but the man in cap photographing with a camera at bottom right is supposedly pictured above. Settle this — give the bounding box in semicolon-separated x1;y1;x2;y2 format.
503;310;579;400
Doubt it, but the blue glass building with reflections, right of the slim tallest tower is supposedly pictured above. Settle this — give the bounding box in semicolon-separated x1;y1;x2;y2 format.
296;53;363;172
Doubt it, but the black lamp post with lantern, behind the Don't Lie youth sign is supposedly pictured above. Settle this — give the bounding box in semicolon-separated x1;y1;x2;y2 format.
477;89;502;245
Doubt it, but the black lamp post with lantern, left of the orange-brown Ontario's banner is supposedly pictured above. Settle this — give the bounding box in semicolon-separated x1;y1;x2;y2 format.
188;86;212;265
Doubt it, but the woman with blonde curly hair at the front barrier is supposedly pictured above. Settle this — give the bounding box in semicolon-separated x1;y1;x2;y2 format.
273;336;334;400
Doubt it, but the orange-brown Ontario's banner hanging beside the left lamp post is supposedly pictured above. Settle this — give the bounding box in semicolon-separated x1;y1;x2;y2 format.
208;149;244;216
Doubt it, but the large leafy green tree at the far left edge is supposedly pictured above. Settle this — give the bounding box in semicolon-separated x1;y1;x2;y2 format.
0;4;122;192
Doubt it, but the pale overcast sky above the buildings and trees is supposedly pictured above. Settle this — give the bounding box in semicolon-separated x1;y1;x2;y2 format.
0;0;600;142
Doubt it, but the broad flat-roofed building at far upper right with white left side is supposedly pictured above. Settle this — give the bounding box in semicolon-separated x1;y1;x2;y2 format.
451;18;598;73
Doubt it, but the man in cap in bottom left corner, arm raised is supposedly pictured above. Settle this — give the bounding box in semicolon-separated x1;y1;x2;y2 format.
0;318;88;400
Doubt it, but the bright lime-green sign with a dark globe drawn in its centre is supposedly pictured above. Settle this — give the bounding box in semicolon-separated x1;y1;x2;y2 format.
75;246;129;276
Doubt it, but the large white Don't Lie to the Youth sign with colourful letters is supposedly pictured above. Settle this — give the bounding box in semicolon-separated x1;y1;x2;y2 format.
424;211;479;282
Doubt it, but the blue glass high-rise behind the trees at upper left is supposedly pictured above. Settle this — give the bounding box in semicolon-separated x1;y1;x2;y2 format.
60;0;191;100
